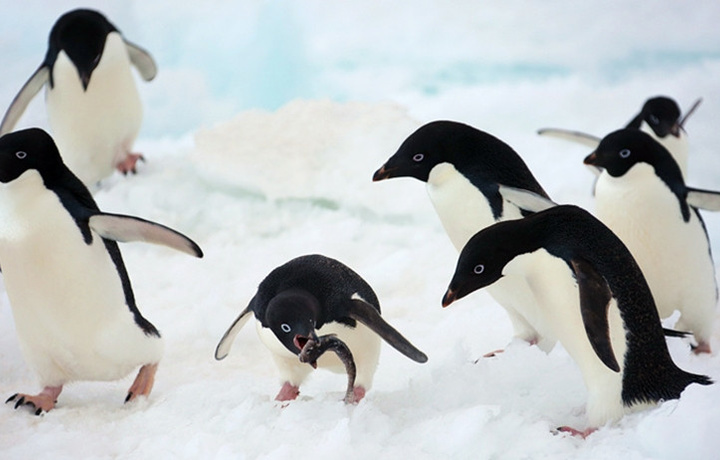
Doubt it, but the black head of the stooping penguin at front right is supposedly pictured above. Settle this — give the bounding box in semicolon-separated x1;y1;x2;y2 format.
442;222;517;307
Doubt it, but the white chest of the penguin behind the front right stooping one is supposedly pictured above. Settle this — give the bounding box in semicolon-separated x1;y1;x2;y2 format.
427;163;522;251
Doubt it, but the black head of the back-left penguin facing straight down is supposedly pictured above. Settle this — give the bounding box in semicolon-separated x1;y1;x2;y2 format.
45;9;117;90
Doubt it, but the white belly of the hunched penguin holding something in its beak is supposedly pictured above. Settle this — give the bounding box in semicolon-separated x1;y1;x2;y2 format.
256;321;381;390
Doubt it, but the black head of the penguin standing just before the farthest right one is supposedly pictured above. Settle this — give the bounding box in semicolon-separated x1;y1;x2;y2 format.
584;128;680;177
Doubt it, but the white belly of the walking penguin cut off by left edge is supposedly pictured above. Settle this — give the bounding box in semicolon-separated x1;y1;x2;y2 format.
0;171;163;386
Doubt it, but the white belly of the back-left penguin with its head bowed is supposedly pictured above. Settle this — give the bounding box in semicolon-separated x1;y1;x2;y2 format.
46;33;142;185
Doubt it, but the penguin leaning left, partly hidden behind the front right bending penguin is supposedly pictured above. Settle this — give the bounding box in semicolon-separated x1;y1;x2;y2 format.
373;121;555;356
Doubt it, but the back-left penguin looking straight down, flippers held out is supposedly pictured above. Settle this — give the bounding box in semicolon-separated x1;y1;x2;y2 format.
0;9;157;189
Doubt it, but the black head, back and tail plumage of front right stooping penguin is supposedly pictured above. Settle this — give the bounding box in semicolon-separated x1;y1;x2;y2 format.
451;205;712;406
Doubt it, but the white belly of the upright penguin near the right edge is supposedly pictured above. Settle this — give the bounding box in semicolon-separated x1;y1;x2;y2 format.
596;164;717;340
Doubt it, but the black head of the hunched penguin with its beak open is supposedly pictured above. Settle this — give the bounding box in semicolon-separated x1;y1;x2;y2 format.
265;289;321;355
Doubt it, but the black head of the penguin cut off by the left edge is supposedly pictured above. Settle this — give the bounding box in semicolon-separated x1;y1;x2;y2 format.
0;128;66;183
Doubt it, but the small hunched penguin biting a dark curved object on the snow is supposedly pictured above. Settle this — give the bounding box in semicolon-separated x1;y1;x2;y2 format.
215;254;427;403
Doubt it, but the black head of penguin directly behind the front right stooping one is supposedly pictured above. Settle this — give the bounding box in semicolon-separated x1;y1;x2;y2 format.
373;121;477;182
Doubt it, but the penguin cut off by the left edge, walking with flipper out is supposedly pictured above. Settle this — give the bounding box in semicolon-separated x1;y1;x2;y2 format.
0;128;202;415
